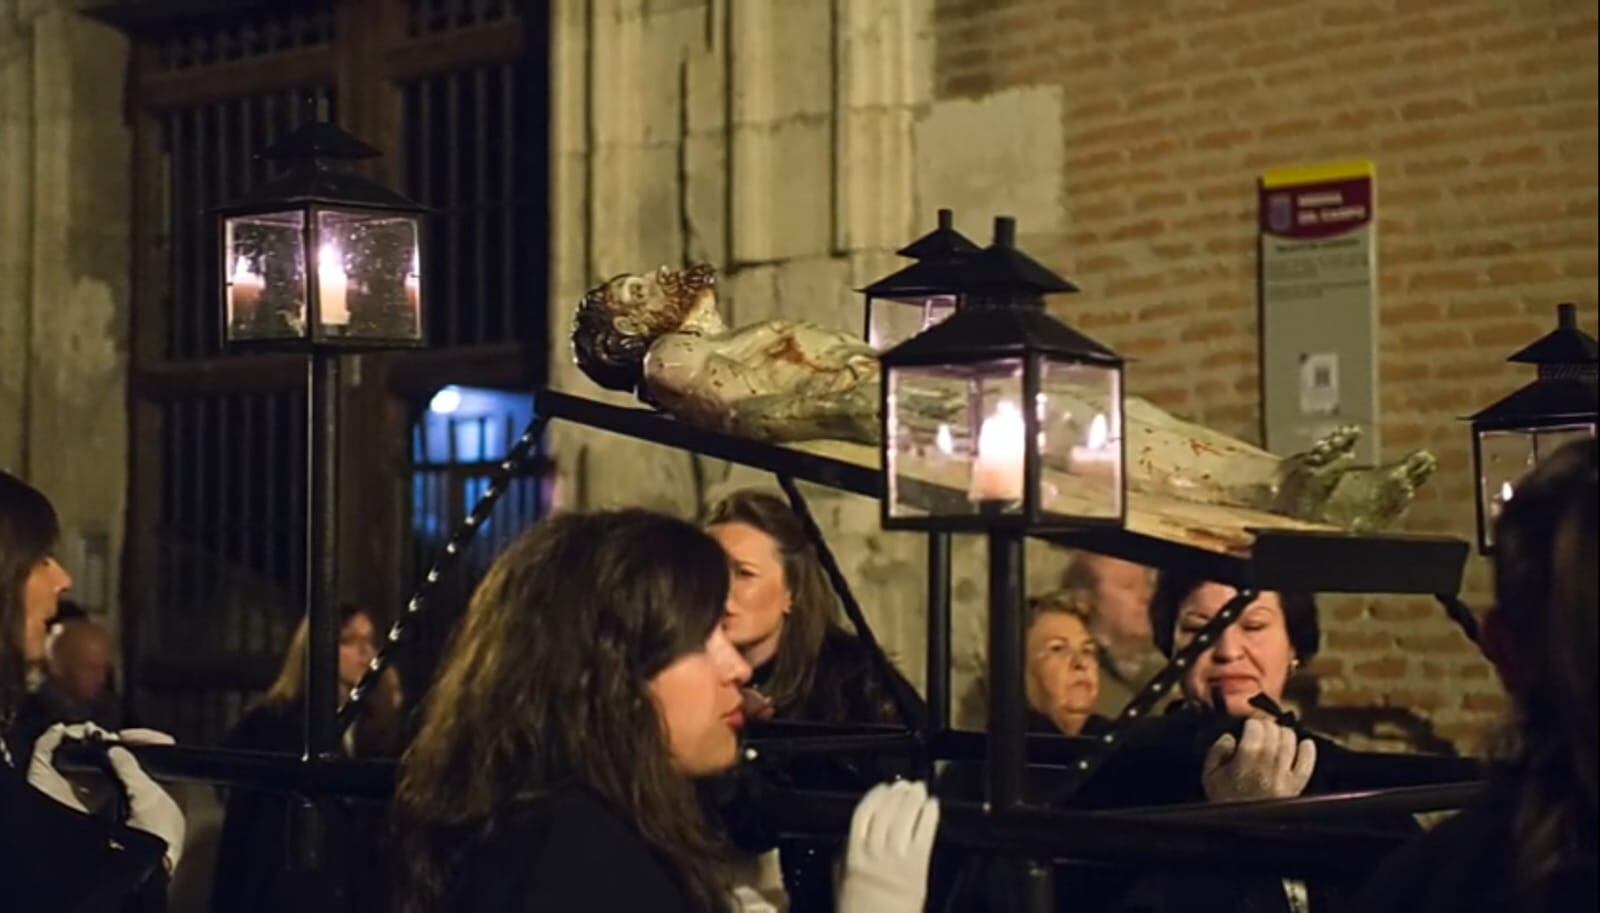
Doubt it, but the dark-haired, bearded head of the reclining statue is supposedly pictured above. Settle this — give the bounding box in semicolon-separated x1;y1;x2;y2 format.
573;264;723;390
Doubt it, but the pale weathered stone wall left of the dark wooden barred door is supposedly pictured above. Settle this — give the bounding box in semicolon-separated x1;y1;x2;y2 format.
0;0;130;636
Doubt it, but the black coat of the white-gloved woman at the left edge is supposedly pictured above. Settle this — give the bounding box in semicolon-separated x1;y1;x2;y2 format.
0;763;166;913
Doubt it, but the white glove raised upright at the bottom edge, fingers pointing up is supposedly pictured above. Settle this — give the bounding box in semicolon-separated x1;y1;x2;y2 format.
838;782;939;913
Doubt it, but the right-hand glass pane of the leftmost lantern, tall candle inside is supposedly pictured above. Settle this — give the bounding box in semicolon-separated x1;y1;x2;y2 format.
317;209;422;342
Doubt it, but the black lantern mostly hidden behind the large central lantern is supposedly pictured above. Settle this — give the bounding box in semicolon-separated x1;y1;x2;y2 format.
861;209;981;352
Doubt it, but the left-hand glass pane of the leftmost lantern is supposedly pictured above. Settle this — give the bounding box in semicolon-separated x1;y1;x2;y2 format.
222;209;306;342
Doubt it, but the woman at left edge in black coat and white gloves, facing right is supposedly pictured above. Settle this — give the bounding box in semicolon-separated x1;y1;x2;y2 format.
0;472;184;913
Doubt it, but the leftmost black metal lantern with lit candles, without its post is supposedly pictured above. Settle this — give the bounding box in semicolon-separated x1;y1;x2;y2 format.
218;122;426;350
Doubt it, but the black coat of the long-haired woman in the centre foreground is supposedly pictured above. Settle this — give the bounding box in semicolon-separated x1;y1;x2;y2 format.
438;787;690;913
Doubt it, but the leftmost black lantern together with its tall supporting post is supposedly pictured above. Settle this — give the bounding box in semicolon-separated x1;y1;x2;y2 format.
218;120;426;760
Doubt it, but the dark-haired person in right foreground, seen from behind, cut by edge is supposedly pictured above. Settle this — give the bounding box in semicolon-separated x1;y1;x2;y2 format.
1362;438;1600;913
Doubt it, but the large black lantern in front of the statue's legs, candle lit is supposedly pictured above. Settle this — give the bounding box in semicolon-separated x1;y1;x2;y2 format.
882;217;1126;531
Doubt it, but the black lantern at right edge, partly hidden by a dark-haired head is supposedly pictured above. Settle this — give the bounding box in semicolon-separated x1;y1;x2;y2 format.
1472;304;1597;555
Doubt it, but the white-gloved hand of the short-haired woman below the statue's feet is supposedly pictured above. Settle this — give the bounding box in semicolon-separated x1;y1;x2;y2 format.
1202;718;1317;803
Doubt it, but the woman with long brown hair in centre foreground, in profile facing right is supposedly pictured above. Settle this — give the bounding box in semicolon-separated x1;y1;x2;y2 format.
395;510;750;913
